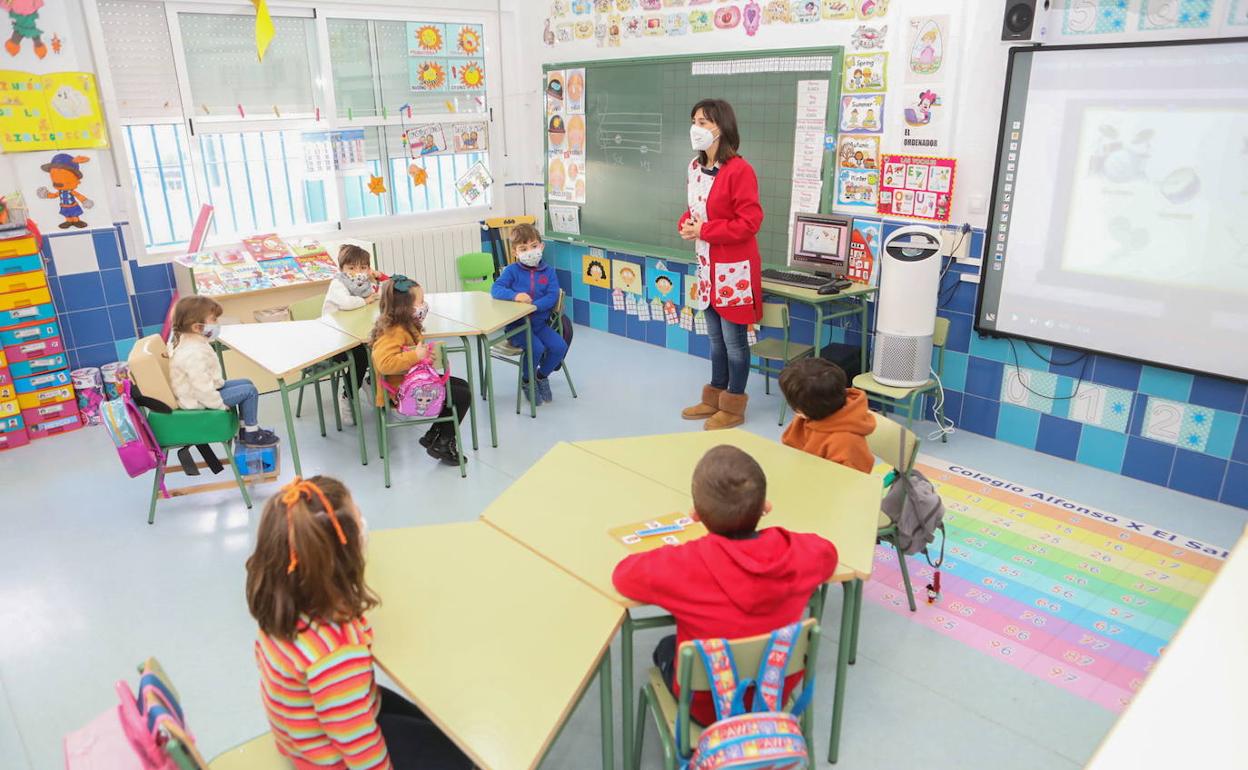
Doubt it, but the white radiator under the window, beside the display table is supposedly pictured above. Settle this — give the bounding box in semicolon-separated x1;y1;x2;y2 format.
372;222;482;292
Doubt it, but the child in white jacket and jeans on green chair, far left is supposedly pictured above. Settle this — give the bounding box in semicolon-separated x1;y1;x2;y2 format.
168;296;277;447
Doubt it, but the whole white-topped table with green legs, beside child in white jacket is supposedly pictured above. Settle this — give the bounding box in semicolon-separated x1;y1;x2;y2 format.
220;321;368;475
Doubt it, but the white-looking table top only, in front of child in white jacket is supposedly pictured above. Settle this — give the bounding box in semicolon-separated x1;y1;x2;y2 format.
214;321;359;377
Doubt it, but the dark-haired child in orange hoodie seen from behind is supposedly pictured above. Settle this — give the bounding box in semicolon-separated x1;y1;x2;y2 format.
780;358;875;473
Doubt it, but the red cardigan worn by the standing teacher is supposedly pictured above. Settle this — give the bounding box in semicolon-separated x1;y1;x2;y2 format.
676;156;763;323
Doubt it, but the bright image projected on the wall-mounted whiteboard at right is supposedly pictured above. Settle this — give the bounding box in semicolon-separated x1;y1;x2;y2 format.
1061;105;1248;291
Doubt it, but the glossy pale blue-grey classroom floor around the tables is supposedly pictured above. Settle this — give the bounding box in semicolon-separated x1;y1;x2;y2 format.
0;327;1248;770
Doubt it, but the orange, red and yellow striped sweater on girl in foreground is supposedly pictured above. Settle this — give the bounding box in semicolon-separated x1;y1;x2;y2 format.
256;618;391;770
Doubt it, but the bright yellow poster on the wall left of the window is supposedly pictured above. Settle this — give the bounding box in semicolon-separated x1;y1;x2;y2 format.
0;70;109;152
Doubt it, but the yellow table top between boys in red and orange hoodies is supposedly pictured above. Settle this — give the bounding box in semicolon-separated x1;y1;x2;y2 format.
575;431;882;580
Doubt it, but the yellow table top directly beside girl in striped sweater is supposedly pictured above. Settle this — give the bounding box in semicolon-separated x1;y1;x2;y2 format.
366;522;623;770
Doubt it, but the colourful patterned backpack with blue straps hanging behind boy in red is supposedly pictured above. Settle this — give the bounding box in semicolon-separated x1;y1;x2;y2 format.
676;620;815;770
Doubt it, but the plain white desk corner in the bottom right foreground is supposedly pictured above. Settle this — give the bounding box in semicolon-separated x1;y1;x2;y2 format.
1088;533;1248;770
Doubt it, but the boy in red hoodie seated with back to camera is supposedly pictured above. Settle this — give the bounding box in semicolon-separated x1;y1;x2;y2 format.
612;446;836;725
